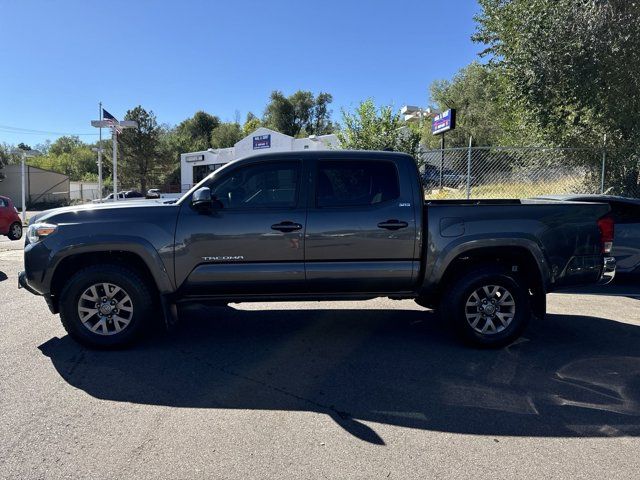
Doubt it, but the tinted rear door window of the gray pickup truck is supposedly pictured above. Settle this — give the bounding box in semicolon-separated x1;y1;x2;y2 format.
316;160;400;207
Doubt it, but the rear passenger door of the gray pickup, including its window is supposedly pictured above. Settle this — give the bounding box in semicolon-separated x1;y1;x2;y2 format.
305;157;418;293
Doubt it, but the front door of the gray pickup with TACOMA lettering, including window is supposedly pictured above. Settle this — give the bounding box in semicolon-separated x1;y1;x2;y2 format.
175;160;306;296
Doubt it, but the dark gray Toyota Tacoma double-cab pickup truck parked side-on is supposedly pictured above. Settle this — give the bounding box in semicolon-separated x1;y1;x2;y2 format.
19;151;615;348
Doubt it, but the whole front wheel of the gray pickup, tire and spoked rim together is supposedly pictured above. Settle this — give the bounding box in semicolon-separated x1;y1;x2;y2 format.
60;264;153;348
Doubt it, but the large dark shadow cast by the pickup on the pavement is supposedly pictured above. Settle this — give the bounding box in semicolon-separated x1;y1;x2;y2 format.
39;305;640;445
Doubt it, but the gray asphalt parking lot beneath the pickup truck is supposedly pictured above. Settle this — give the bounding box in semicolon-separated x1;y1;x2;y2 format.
0;238;640;479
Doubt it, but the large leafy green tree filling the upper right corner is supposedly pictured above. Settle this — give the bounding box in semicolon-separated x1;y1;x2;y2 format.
474;0;640;193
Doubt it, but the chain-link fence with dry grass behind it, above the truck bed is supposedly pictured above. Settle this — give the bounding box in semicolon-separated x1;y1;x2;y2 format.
420;147;640;199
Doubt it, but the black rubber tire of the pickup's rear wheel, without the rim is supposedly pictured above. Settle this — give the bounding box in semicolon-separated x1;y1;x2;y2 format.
440;266;532;348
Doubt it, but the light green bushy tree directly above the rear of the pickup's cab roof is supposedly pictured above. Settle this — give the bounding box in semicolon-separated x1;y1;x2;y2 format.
337;99;420;157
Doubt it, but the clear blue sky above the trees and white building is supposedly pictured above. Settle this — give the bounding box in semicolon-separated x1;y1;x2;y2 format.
0;0;481;145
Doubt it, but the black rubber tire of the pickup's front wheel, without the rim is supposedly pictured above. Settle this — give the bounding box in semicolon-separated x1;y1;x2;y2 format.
60;264;154;349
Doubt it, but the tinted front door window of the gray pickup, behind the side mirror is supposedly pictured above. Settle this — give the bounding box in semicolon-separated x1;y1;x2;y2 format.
211;162;300;209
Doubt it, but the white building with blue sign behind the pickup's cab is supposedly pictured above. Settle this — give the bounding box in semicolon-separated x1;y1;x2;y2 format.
180;127;339;192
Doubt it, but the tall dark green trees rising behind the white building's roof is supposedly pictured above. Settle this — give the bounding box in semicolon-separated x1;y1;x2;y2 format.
263;90;334;137
